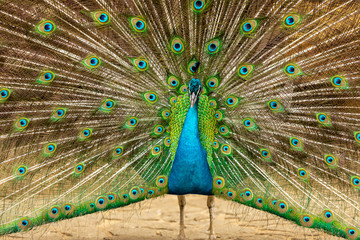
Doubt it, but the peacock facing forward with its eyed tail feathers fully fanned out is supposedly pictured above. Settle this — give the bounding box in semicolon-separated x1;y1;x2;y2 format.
0;0;360;240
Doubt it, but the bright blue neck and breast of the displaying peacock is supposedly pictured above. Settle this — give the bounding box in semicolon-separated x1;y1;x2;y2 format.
169;103;212;195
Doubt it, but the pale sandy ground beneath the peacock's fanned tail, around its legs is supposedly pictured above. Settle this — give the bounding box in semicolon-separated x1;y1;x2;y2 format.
2;195;342;240
